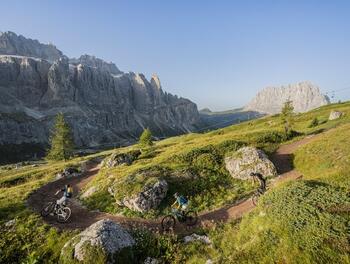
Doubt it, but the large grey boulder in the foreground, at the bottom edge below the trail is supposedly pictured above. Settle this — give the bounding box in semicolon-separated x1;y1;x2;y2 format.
60;219;135;263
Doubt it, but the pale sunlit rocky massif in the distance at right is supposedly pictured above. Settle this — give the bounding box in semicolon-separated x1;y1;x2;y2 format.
244;82;329;114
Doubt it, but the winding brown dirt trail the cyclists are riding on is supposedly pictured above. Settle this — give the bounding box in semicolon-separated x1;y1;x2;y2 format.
27;135;319;233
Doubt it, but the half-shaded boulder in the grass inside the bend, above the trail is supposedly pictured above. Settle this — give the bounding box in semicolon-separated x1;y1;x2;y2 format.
121;180;168;213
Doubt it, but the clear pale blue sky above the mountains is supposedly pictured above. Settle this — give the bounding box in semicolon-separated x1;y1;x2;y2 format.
0;0;350;110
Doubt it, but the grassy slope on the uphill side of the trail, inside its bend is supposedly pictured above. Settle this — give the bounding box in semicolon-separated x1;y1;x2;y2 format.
81;100;350;217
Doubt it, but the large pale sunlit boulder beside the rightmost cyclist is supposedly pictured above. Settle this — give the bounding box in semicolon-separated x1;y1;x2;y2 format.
225;147;277;180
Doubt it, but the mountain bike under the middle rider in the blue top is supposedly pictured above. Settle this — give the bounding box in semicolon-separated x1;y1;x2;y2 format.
162;208;198;231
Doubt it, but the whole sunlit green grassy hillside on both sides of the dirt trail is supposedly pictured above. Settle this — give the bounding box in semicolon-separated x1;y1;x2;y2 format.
0;100;350;263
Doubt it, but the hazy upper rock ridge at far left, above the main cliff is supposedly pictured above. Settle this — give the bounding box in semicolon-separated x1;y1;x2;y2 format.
0;31;63;61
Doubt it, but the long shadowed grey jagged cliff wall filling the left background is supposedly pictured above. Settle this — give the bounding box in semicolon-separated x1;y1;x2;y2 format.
0;33;199;151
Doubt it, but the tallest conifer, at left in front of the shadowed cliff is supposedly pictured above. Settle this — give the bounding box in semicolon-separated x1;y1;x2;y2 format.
46;113;74;160
